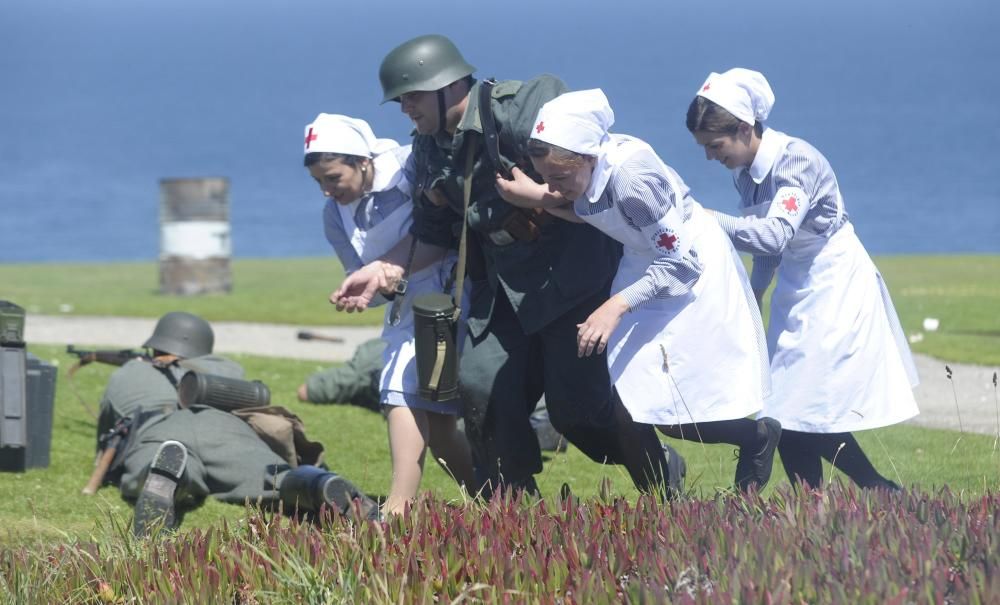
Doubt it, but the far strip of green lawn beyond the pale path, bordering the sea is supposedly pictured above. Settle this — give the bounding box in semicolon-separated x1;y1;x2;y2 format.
0;255;1000;365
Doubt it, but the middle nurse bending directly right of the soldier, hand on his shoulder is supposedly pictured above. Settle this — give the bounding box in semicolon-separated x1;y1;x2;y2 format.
498;89;781;489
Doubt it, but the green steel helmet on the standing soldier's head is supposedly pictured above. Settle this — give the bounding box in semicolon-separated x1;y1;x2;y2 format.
378;34;476;103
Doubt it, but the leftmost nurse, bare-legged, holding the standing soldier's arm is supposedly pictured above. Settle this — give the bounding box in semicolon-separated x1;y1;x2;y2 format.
304;113;473;513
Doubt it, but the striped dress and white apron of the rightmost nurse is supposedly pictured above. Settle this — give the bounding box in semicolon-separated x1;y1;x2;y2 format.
716;129;918;433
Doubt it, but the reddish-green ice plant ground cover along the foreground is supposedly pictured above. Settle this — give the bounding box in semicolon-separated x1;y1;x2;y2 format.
0;481;1000;604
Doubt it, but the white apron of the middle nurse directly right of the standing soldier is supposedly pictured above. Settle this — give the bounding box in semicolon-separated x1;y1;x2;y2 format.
581;156;767;425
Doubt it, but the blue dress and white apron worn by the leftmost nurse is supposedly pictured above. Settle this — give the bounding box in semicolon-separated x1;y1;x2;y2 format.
338;179;459;414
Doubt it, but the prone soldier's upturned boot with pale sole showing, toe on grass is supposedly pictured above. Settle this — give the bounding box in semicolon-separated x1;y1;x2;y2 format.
132;441;187;537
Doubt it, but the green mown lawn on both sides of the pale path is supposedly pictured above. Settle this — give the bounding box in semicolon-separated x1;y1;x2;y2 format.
0;256;1000;544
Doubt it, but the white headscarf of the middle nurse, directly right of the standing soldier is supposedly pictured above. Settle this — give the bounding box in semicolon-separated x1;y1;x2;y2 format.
531;88;615;156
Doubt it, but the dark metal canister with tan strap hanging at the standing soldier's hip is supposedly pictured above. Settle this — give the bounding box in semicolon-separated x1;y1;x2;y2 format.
413;293;458;401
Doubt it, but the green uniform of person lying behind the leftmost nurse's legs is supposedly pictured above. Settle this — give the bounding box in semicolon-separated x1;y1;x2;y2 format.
298;338;386;411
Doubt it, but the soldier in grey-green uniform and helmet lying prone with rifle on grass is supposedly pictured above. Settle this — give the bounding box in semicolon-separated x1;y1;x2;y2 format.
98;312;378;534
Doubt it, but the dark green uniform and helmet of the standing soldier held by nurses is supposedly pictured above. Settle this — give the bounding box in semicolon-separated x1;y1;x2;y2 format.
380;36;666;493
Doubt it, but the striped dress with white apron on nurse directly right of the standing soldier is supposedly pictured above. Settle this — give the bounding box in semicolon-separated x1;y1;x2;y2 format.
574;135;769;425
